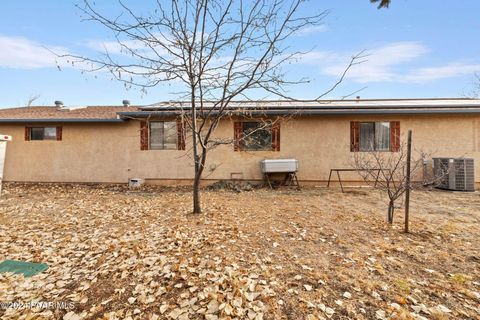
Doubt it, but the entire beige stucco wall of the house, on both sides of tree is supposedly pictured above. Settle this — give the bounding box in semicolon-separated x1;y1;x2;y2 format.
0;115;480;185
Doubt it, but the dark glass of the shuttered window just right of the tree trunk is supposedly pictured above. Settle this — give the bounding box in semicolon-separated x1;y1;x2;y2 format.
243;122;272;151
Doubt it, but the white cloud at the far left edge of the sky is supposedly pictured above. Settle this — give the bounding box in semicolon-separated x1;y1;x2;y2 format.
0;35;68;69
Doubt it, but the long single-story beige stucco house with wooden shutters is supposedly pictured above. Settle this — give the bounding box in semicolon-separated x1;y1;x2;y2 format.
0;98;480;186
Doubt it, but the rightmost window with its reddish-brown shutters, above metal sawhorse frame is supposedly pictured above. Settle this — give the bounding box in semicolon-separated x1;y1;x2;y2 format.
350;121;400;152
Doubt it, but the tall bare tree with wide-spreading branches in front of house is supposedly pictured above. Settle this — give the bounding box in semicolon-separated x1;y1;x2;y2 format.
63;0;362;213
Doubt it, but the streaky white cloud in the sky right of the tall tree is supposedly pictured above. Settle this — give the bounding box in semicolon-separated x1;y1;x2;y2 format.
300;42;480;83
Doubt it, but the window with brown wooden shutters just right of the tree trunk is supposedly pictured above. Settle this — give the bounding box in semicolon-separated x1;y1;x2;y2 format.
234;121;280;151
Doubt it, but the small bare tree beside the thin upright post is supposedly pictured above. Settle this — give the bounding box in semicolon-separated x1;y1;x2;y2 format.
352;134;434;223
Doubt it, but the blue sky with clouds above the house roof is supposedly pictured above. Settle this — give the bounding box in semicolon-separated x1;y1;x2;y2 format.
0;0;480;107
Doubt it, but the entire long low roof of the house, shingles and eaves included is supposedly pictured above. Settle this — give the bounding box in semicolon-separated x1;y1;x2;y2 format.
0;98;480;123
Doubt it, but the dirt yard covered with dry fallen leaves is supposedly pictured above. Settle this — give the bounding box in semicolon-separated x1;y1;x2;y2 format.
0;185;480;320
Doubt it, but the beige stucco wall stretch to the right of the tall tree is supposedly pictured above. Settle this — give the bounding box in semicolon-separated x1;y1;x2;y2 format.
210;116;480;183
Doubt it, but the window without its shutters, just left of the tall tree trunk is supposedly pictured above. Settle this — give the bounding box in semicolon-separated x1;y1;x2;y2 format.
150;121;177;150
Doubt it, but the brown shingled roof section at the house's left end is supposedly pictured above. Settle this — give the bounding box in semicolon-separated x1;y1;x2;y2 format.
0;106;138;122
